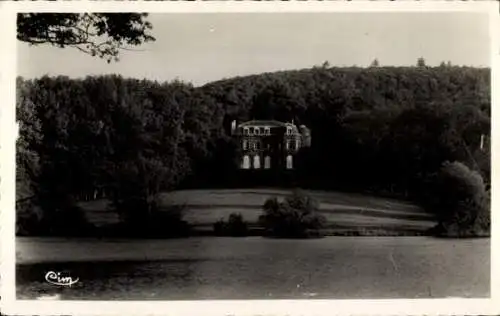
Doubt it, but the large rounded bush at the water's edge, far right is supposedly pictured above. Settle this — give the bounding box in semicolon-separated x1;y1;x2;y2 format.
428;162;490;237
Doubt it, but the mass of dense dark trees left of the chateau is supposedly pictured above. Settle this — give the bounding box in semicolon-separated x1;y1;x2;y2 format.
17;76;236;235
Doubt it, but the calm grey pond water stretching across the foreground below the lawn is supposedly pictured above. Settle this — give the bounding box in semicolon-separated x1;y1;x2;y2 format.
16;237;490;300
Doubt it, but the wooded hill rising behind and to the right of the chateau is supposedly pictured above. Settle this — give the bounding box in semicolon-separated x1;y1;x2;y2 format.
201;67;490;193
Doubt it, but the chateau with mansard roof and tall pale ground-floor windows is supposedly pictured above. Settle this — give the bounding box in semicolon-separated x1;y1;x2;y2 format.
231;120;311;170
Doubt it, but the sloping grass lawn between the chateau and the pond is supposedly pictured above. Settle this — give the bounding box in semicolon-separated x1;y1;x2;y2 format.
77;189;435;235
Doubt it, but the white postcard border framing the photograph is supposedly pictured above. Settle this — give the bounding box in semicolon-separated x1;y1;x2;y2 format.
0;1;500;315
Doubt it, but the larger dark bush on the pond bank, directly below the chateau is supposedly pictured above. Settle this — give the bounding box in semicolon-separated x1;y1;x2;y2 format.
259;191;326;238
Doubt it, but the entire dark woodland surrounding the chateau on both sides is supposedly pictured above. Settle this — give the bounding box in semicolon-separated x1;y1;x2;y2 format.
17;67;490;237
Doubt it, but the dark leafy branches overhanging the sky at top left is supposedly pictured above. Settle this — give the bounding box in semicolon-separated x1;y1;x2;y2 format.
17;13;155;63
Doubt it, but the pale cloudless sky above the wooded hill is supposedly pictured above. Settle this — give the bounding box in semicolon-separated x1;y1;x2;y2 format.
17;12;490;86
